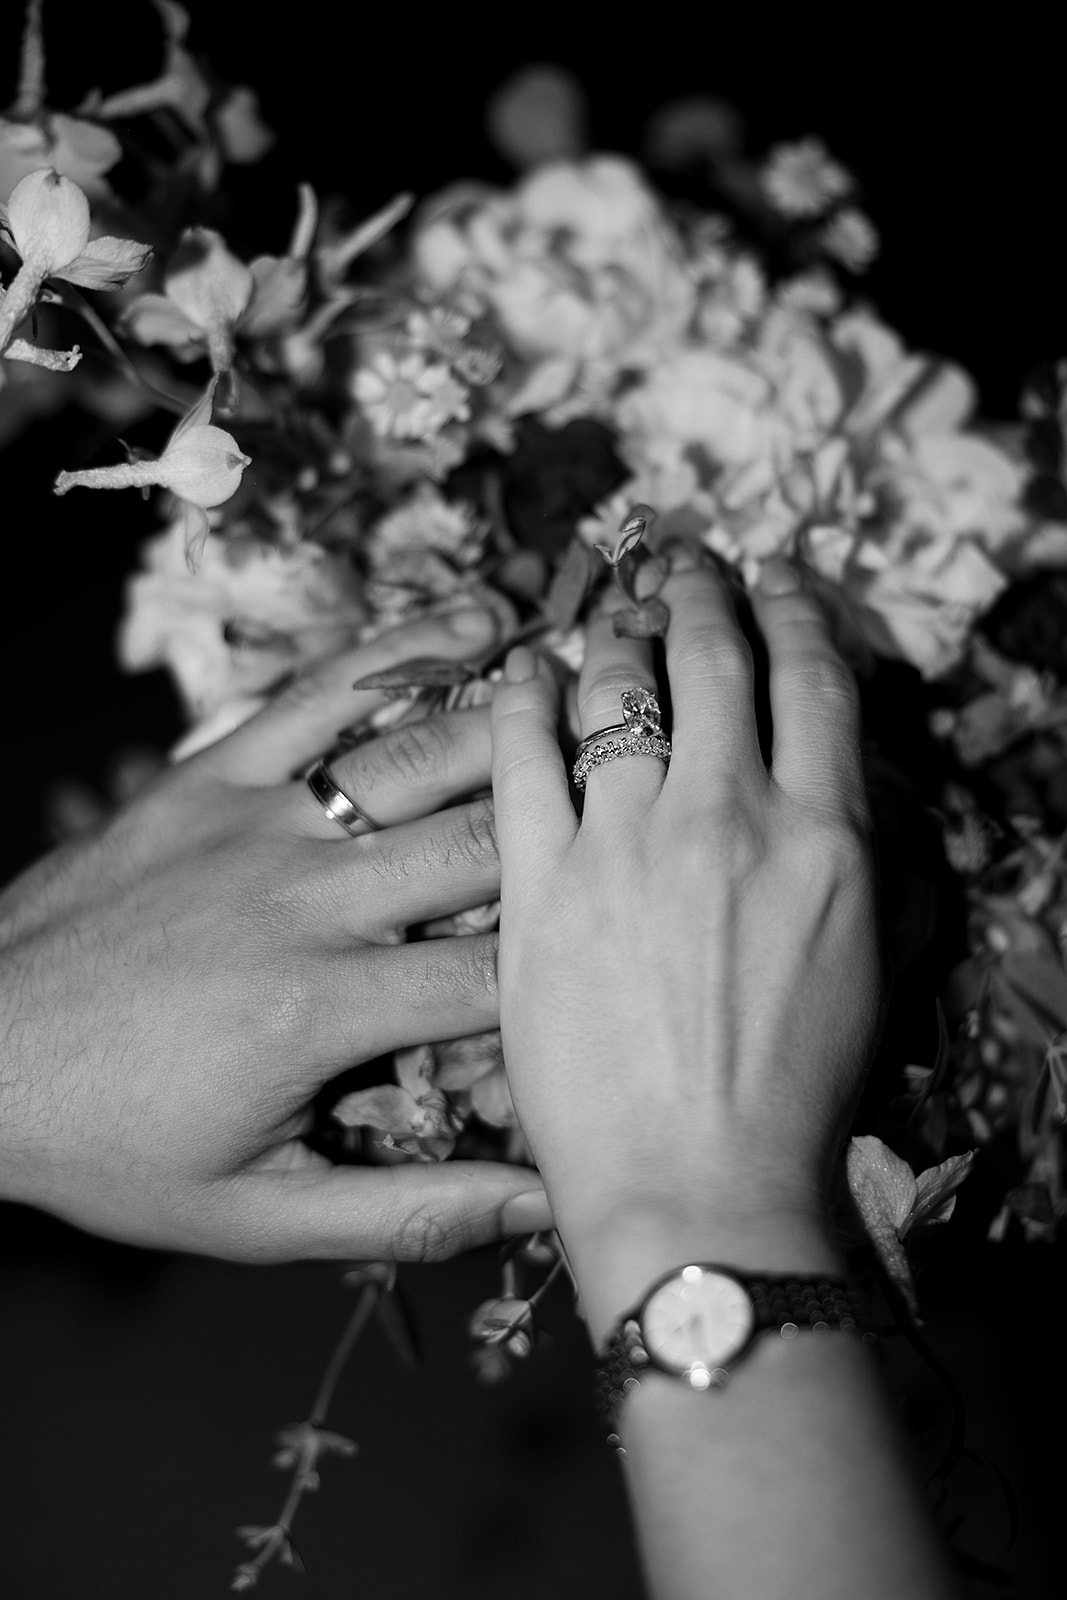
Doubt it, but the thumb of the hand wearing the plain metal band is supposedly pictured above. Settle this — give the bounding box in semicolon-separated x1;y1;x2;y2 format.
199;1162;555;1262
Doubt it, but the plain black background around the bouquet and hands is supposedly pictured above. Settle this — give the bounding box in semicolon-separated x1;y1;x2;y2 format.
0;0;1067;1600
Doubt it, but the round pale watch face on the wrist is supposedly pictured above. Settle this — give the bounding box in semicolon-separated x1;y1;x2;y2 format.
641;1267;755;1373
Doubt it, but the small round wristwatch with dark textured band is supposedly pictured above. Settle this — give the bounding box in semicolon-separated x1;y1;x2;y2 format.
597;1261;869;1446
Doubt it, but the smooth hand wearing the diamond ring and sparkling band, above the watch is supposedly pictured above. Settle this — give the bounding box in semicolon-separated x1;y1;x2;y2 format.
493;566;881;1320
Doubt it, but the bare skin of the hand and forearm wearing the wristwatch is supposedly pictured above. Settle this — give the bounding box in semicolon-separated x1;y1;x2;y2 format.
493;565;955;1600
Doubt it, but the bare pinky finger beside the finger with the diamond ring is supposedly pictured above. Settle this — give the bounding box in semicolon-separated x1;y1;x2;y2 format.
493;645;577;878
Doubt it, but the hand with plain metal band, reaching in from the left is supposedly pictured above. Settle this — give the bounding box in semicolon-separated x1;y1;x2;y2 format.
0;613;550;1261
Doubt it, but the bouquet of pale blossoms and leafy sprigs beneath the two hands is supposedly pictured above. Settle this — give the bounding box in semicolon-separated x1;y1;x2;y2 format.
0;0;1067;1587
